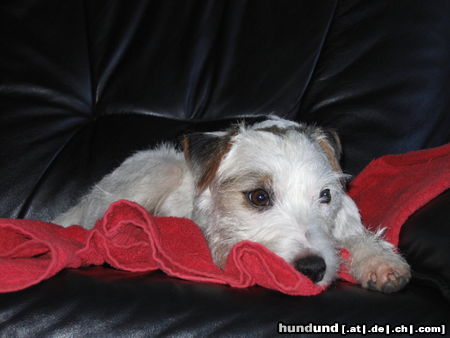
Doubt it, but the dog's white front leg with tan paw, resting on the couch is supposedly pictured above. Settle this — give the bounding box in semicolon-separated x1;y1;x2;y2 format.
334;195;411;293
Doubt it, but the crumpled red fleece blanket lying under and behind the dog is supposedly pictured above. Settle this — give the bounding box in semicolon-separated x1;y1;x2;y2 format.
0;145;450;295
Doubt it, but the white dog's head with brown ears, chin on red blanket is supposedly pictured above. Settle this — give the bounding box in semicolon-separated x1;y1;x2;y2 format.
183;116;344;285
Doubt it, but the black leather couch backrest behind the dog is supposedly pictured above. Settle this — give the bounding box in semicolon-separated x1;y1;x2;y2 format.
0;0;450;219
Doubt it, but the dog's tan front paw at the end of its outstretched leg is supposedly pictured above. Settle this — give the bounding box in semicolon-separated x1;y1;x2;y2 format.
357;254;411;293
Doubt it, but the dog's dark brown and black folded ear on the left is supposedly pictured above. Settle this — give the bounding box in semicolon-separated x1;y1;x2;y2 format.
181;132;231;192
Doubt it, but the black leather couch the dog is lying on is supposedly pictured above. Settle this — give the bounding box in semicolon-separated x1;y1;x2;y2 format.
0;0;450;337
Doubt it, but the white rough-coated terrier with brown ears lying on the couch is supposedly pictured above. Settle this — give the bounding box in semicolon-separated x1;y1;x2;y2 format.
54;115;410;293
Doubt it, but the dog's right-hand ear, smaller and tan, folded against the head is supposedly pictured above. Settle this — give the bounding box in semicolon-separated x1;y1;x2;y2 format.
310;127;342;172
